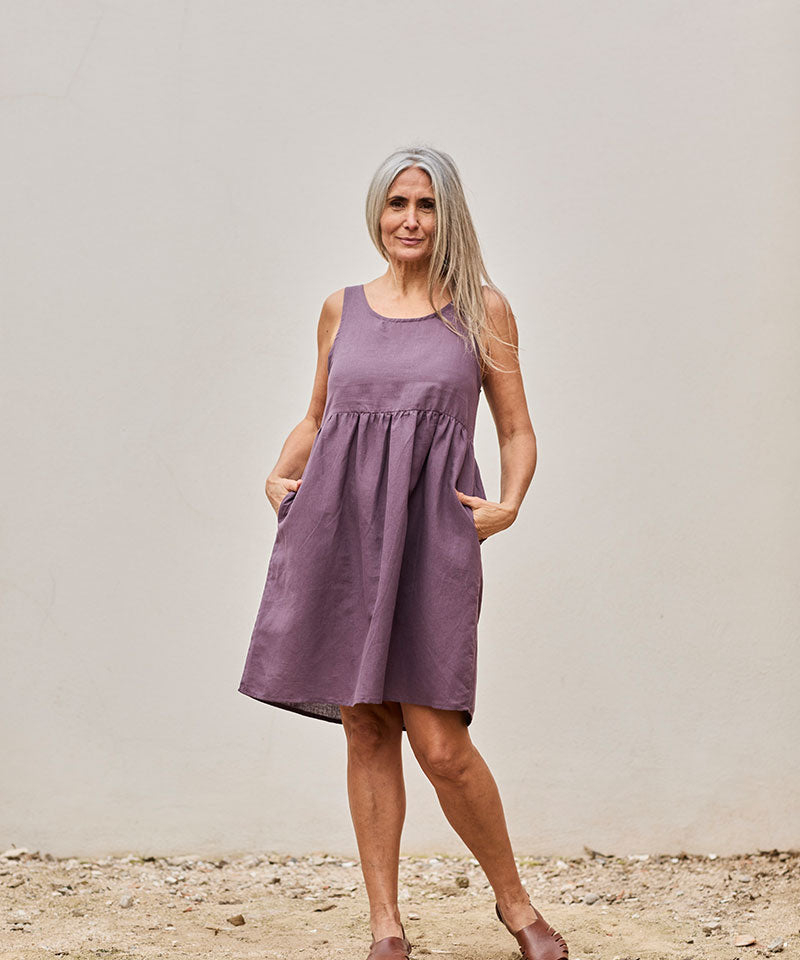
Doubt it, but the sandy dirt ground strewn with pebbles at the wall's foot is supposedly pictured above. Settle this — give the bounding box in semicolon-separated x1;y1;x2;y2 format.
0;848;800;960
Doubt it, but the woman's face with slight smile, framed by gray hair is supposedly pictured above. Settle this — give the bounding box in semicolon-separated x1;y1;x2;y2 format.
381;167;436;261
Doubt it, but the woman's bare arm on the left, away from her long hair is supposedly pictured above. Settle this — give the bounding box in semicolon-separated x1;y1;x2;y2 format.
265;288;344;511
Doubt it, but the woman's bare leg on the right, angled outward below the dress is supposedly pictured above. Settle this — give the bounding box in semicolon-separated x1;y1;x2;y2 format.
401;703;536;930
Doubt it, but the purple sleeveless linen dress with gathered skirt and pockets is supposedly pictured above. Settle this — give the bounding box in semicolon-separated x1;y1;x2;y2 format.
239;286;486;730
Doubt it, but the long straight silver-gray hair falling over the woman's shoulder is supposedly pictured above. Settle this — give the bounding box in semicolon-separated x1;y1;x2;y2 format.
366;145;519;371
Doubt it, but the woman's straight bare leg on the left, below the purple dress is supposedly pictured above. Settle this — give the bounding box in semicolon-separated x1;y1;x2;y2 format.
341;702;406;940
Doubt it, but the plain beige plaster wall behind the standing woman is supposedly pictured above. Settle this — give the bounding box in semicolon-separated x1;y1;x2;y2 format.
0;0;800;854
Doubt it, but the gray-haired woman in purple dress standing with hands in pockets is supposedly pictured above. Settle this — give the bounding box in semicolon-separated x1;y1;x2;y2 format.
239;147;567;960
